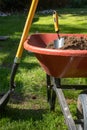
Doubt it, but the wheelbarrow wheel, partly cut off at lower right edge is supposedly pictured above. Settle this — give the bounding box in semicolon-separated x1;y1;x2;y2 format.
77;94;87;130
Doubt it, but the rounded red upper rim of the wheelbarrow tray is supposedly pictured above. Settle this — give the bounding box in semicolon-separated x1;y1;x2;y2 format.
24;33;87;57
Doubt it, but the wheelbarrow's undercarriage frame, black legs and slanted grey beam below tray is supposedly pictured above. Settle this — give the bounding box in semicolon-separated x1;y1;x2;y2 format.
46;74;87;130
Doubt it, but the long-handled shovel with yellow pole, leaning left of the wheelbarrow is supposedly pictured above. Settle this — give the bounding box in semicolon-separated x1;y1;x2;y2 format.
0;0;39;110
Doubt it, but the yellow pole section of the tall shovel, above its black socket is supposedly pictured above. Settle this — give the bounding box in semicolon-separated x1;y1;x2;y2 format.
16;0;38;59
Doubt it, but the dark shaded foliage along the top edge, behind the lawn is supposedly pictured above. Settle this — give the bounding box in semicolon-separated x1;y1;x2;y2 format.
0;0;87;11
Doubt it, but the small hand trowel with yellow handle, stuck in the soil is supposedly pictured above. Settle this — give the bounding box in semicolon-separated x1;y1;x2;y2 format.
53;11;64;48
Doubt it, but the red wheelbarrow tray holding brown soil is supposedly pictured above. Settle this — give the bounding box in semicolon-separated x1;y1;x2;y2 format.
24;33;87;78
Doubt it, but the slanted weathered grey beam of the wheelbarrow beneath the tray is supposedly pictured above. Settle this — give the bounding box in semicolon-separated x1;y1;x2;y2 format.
53;78;76;130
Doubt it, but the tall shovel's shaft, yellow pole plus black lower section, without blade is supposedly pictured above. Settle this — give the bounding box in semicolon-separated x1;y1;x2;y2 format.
10;0;38;93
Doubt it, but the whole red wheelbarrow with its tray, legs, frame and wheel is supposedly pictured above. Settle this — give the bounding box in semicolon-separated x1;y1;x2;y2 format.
24;33;87;130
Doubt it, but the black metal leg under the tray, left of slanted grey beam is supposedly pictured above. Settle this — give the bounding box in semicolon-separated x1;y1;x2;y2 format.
46;75;56;111
